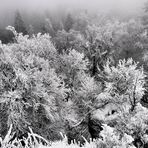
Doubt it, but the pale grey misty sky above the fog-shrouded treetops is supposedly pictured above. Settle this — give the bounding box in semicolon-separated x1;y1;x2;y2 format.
0;0;148;27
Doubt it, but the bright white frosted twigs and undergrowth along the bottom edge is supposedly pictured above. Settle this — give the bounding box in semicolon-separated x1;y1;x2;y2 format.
0;125;135;148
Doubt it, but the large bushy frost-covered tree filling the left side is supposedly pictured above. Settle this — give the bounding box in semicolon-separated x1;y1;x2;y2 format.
0;27;68;139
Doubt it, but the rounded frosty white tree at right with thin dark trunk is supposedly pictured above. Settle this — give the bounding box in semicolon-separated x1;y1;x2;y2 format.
98;59;145;111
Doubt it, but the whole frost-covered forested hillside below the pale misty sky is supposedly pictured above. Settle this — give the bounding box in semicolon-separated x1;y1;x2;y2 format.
0;0;148;148
